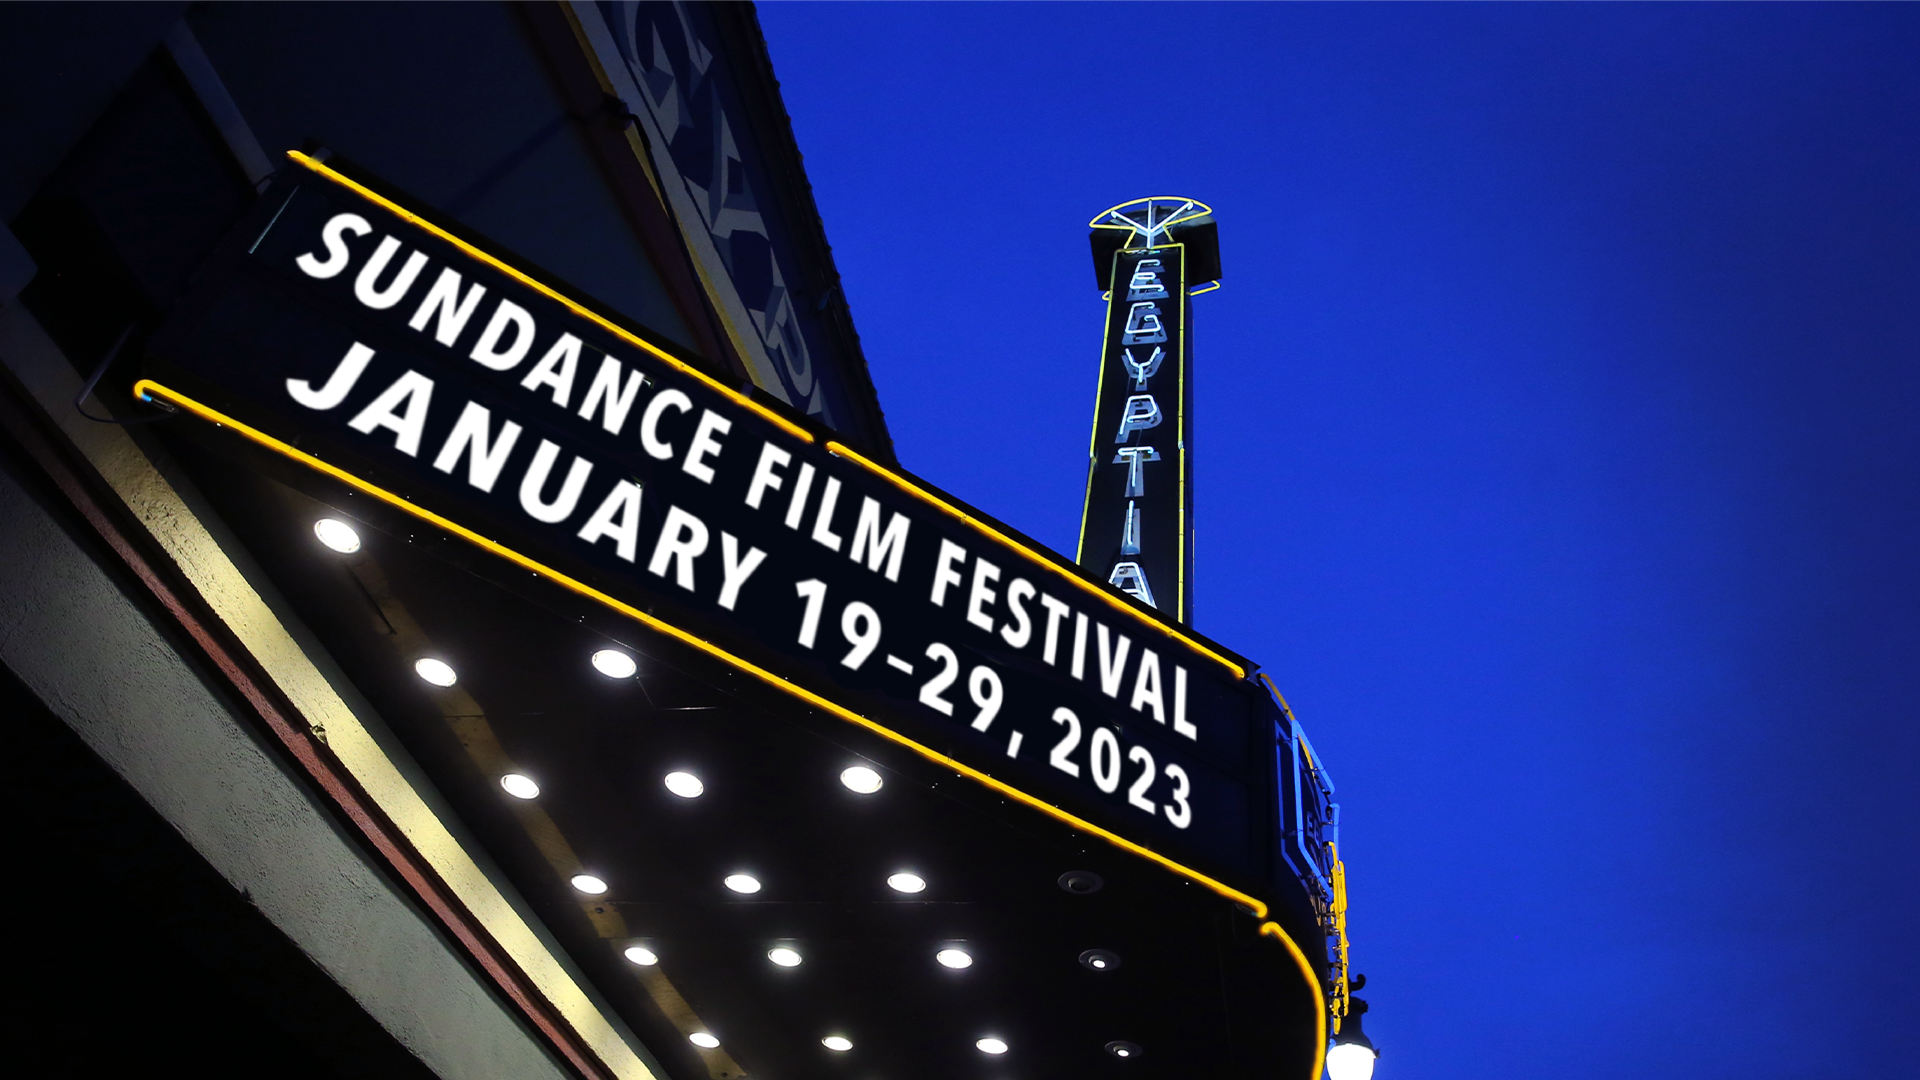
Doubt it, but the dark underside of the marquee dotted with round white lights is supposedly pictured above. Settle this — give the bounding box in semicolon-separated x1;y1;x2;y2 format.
169;440;1317;1080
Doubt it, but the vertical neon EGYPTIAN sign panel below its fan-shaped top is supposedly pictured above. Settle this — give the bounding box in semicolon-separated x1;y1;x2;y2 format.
1077;244;1192;623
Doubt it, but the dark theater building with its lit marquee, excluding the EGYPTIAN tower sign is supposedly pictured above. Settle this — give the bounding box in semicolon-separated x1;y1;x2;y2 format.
0;0;1344;1080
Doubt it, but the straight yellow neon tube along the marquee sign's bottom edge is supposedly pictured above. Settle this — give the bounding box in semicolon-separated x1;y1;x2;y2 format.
132;379;1267;919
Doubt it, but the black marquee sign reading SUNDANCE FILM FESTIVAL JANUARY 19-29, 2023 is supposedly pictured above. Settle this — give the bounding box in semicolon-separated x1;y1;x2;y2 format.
136;156;1273;913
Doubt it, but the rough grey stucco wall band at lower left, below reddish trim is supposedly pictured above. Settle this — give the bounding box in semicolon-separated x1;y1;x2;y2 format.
0;455;568;1080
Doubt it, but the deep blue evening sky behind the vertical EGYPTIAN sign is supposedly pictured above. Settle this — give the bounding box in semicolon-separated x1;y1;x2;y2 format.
760;0;1920;1080
